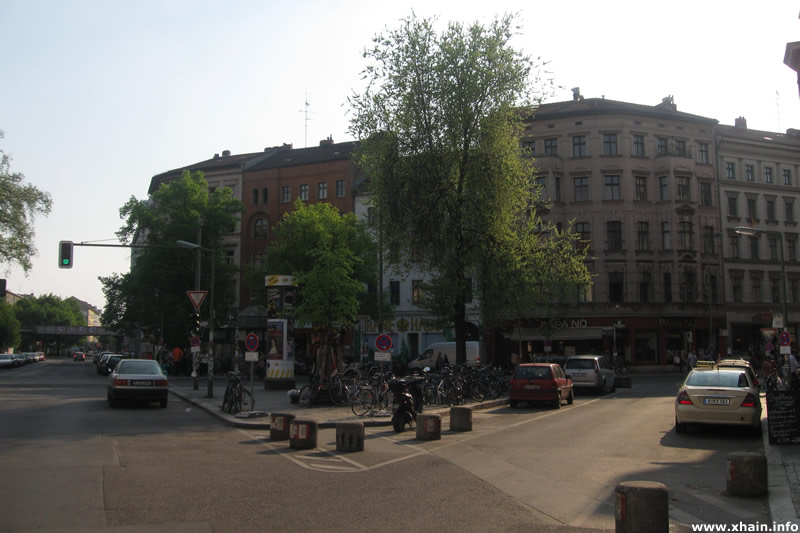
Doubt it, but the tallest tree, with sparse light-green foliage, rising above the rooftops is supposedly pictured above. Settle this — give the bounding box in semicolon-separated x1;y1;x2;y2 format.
351;15;592;362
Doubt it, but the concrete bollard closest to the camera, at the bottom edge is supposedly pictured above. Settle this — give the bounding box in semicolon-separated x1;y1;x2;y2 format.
615;481;669;533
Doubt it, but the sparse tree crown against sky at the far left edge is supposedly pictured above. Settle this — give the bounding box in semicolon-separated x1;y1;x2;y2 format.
0;131;53;274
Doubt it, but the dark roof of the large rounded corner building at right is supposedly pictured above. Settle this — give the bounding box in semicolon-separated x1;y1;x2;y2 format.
533;98;718;125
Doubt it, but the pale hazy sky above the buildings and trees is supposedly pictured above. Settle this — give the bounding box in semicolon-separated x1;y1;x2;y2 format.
0;0;800;308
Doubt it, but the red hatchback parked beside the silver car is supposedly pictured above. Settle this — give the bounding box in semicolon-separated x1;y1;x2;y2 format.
509;363;575;409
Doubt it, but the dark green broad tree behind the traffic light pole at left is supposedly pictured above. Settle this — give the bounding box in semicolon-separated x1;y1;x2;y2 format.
100;171;243;345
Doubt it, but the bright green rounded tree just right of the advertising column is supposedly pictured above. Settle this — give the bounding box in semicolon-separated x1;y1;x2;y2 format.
262;199;376;374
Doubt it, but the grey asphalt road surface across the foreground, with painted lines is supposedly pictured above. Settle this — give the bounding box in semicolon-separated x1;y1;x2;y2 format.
0;360;769;533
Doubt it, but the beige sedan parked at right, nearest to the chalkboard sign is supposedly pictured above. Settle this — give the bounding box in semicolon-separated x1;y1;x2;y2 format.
675;368;761;433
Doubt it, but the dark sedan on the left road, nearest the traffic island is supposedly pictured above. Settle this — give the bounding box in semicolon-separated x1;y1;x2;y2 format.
107;356;169;407
